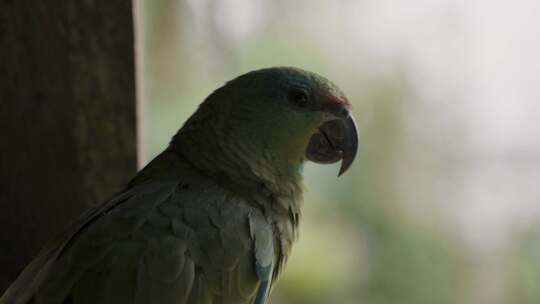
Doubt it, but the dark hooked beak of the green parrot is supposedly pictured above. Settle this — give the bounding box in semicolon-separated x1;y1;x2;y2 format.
305;104;358;176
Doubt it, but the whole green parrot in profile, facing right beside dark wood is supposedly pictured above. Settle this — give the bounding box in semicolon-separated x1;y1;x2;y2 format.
0;67;358;304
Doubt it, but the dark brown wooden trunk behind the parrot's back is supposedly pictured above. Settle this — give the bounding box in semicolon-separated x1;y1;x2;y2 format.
0;0;136;294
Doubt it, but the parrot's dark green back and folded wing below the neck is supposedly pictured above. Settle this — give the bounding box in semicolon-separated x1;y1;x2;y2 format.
0;155;279;304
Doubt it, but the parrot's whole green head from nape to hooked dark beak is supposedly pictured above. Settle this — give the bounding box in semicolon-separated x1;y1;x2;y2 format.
173;67;358;188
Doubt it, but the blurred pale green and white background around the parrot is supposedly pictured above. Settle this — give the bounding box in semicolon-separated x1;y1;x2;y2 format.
135;0;540;304
